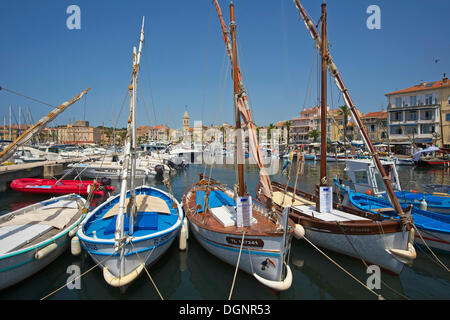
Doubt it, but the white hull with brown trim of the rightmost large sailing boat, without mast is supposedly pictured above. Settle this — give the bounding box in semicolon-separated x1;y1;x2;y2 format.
264;182;413;275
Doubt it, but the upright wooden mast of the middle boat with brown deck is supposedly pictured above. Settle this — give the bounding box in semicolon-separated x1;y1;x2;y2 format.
230;2;245;197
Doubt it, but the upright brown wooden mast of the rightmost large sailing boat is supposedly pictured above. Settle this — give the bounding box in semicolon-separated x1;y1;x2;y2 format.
316;3;328;211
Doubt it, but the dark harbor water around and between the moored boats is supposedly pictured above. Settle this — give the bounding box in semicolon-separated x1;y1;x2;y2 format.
0;161;450;300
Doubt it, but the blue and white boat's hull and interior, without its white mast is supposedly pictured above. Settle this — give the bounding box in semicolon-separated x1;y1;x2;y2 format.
77;186;184;287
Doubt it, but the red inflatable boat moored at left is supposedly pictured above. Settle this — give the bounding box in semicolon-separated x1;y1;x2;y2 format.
11;178;114;196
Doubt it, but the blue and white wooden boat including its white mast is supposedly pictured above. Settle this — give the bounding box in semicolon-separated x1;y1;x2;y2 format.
77;19;183;289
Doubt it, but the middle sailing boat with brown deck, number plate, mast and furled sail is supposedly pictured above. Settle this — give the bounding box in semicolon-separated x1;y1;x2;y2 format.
182;1;294;291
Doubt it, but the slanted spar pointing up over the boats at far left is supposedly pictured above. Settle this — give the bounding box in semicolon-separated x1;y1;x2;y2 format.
0;87;90;162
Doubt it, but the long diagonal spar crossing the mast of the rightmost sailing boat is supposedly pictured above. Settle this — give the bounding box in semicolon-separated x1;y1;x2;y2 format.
294;0;405;217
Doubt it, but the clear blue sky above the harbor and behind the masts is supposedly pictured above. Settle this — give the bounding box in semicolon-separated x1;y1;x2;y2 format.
0;0;450;128
